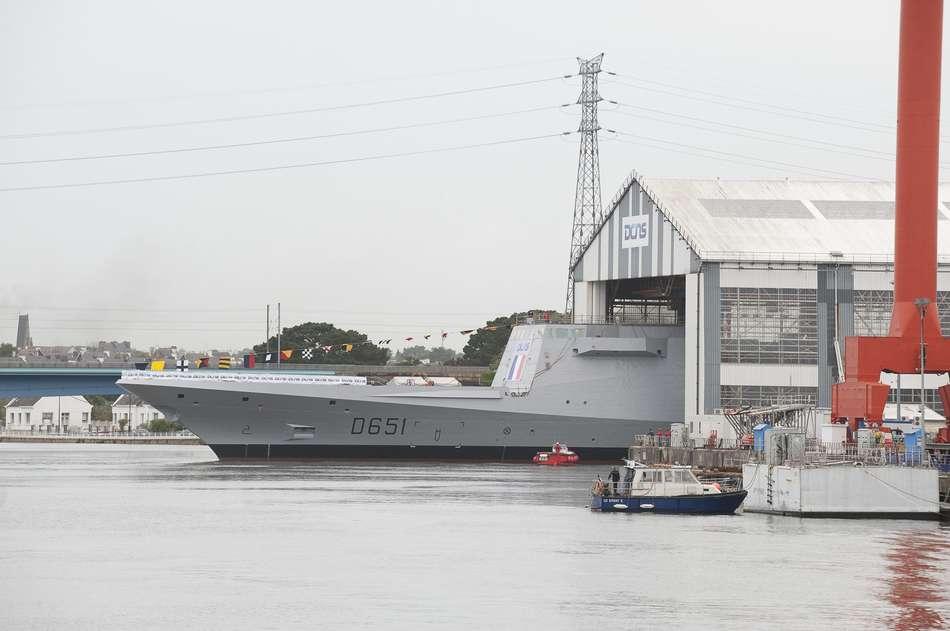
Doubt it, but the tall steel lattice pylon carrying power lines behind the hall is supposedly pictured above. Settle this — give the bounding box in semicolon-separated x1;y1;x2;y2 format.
565;53;604;315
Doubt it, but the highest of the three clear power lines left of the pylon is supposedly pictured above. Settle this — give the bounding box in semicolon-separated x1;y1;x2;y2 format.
0;75;574;140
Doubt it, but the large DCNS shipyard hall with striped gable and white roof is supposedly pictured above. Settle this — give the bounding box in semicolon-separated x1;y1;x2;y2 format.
573;173;950;437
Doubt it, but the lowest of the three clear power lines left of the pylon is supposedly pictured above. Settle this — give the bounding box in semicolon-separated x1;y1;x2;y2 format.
0;131;577;193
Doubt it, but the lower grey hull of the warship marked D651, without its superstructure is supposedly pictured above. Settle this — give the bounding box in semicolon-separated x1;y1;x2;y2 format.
122;382;658;462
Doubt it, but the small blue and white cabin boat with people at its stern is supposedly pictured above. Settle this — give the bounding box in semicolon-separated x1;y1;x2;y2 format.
590;460;747;515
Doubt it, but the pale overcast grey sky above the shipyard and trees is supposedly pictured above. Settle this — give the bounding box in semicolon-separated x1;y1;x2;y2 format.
0;0;947;349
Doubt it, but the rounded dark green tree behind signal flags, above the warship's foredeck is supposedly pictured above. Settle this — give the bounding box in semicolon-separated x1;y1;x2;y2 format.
254;322;389;365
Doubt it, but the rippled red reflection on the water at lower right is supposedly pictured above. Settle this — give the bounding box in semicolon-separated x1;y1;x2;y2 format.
882;528;950;631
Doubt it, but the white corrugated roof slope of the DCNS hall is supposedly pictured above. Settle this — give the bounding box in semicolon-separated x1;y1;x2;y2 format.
625;175;950;263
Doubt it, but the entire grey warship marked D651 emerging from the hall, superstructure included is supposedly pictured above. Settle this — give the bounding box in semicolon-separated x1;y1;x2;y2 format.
118;324;685;461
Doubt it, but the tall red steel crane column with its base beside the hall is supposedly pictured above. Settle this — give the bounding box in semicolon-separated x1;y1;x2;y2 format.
831;0;950;430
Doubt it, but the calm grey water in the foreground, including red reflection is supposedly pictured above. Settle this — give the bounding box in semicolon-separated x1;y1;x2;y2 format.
0;443;950;630
